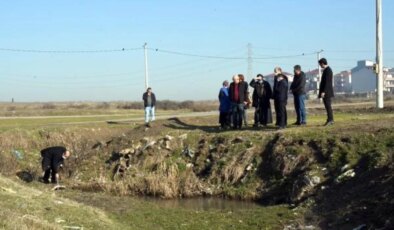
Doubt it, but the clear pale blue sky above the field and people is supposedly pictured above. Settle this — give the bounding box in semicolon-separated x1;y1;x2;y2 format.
0;0;394;102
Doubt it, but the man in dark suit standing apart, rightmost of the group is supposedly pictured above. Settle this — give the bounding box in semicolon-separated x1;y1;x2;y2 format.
319;58;334;126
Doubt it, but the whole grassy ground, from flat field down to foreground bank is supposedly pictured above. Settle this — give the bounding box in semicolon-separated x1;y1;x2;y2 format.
0;99;394;229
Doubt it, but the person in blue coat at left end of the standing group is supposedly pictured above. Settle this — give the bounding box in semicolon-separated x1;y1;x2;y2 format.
219;81;231;129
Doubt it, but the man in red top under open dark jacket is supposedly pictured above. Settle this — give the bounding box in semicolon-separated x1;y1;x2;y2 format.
229;75;248;129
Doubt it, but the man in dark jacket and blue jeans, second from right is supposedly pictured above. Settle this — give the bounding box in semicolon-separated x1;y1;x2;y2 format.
290;65;306;125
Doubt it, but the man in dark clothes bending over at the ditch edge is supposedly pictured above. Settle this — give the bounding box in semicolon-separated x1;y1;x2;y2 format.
41;146;70;184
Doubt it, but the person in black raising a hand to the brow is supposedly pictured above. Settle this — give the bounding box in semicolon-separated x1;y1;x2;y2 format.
249;74;272;128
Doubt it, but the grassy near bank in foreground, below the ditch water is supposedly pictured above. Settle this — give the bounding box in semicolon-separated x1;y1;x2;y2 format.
0;176;301;230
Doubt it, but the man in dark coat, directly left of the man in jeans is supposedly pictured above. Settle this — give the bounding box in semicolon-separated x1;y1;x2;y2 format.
273;67;289;129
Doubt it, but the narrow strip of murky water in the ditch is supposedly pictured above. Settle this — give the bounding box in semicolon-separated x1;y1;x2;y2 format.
144;197;261;211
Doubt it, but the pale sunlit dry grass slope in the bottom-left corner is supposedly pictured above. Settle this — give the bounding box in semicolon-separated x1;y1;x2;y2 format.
0;175;116;230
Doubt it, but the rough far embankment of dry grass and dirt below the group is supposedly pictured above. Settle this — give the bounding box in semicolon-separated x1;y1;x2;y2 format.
0;114;394;228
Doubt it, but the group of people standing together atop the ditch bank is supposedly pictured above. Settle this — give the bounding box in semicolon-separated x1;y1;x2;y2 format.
219;58;334;129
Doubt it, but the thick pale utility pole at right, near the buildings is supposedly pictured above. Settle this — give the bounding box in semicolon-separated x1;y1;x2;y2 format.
375;0;384;109
